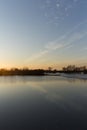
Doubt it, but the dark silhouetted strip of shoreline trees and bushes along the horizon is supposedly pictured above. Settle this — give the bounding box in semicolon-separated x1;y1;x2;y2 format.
0;65;87;76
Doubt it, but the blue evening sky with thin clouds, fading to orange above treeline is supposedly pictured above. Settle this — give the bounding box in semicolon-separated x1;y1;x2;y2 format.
0;0;87;69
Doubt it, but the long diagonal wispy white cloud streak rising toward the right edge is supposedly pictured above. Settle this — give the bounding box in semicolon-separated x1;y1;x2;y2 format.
26;20;87;62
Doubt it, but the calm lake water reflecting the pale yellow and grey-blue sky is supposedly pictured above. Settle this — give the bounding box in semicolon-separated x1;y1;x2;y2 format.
0;76;87;130
